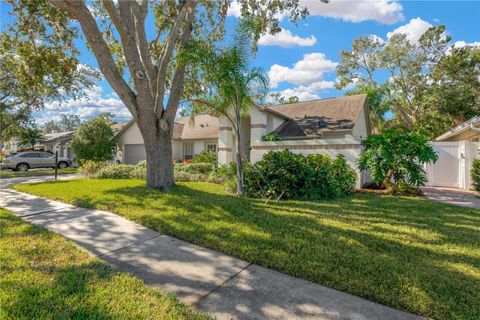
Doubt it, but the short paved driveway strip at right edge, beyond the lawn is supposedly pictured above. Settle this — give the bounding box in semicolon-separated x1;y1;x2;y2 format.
422;187;480;209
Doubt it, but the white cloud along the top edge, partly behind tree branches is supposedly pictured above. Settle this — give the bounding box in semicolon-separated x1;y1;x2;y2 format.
228;0;404;24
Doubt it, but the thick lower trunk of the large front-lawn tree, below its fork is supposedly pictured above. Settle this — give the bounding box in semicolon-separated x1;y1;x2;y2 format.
137;114;175;190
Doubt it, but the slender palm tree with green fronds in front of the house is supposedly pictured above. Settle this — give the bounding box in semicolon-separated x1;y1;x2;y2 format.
193;38;268;195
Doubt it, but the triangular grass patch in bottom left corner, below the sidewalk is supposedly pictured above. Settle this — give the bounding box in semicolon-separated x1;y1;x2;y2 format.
0;209;208;320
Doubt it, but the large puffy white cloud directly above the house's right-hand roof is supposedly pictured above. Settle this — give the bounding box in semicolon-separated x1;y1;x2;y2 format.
268;53;338;88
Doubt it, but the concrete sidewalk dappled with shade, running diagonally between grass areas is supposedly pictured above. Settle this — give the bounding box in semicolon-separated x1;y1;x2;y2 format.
0;189;420;320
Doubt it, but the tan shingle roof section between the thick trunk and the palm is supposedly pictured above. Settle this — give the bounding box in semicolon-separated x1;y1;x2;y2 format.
174;114;219;140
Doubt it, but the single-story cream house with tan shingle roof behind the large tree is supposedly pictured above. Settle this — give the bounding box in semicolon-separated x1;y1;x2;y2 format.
117;94;371;186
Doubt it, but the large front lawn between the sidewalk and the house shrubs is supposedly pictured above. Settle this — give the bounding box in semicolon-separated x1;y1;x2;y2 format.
16;179;480;319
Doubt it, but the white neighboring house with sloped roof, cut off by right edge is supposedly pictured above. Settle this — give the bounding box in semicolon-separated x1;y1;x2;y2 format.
425;116;480;189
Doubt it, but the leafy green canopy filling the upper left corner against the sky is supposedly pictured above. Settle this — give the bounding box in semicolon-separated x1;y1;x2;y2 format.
0;0;98;138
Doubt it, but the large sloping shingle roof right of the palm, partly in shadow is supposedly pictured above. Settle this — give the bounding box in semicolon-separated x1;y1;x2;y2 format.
267;94;367;137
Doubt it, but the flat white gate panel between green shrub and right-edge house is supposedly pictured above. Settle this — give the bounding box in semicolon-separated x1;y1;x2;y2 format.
426;141;461;188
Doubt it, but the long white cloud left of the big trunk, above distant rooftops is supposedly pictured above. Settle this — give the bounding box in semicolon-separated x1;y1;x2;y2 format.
34;86;131;125
